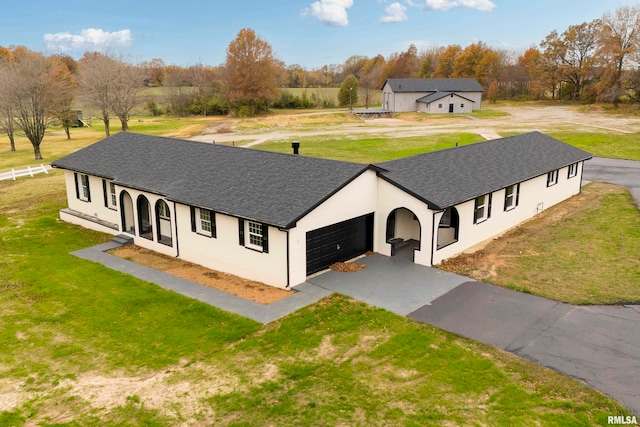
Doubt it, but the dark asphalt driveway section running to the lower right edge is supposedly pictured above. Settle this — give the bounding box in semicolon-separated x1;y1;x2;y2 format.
409;282;640;415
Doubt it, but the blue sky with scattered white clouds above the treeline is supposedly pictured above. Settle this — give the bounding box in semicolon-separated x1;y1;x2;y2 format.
0;0;637;69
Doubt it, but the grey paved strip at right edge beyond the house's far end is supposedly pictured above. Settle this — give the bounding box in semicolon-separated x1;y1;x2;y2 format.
583;157;640;207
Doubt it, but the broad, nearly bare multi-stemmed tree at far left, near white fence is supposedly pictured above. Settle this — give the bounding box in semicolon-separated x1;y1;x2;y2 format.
0;49;69;160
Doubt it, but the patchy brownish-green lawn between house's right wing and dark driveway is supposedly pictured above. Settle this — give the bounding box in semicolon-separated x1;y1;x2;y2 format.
440;182;640;304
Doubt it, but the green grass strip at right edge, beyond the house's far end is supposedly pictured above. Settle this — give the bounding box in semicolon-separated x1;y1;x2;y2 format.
549;132;640;160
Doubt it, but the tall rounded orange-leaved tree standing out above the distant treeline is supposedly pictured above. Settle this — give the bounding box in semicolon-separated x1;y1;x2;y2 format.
225;28;279;115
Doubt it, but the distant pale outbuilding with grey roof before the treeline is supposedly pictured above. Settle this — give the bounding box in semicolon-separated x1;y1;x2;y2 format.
382;79;483;114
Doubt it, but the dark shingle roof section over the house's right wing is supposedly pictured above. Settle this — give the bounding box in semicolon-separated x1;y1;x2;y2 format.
377;132;592;209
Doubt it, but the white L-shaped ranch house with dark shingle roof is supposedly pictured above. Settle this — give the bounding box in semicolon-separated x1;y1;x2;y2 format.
53;132;591;288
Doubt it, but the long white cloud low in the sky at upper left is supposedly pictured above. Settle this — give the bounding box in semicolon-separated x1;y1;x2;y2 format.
44;28;133;52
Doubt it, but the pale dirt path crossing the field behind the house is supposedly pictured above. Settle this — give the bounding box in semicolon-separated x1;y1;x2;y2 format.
191;105;640;147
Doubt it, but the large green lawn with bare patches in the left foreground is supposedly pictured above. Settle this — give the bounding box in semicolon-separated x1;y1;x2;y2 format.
0;171;627;427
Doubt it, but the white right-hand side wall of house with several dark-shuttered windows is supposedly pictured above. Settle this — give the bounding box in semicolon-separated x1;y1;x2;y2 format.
433;163;584;264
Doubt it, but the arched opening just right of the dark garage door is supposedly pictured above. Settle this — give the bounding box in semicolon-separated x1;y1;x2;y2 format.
386;208;422;260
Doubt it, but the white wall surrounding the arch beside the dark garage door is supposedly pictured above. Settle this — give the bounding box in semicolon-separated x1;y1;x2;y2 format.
373;178;433;265
